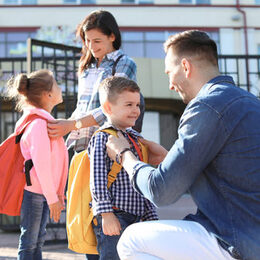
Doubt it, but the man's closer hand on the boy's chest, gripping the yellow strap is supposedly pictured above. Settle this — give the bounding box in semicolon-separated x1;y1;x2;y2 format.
106;132;130;161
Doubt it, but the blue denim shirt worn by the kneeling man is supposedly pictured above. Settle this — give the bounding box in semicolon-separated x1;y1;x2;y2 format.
132;76;260;260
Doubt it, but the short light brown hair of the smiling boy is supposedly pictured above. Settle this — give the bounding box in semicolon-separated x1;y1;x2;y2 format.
99;76;140;104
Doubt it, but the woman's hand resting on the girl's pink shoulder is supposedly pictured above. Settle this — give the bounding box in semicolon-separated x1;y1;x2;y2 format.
48;119;75;138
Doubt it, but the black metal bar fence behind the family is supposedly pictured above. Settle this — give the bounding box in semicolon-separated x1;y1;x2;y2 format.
0;39;260;238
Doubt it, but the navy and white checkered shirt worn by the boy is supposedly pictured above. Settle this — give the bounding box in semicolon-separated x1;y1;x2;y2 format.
88;123;158;220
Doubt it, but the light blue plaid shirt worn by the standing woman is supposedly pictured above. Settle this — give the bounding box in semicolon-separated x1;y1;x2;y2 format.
66;50;136;152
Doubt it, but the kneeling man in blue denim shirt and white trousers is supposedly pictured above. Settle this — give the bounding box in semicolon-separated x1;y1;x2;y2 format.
107;31;260;260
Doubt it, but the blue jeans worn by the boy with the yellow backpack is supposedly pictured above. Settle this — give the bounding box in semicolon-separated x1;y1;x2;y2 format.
92;210;140;260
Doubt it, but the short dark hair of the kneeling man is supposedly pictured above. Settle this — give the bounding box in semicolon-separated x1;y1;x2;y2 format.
164;30;218;66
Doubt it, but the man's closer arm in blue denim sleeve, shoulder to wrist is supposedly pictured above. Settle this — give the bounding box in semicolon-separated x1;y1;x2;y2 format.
106;103;226;206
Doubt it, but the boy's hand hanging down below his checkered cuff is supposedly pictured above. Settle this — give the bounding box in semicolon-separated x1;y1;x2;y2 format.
101;212;122;236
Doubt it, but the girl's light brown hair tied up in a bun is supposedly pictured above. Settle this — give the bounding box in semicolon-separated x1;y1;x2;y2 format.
6;70;54;111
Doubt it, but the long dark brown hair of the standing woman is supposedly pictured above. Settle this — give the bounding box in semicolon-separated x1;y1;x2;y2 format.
76;10;121;74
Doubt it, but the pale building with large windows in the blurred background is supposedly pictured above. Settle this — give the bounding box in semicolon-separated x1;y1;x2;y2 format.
0;0;260;148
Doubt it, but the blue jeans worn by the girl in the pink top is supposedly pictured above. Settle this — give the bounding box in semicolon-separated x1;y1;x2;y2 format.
17;190;49;260
